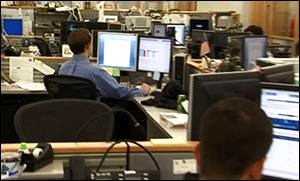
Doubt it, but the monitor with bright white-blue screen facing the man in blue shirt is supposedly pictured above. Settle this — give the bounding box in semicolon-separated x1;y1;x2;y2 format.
97;32;138;71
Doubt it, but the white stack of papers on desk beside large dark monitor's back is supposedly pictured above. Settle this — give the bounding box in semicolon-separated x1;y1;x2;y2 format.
160;113;188;127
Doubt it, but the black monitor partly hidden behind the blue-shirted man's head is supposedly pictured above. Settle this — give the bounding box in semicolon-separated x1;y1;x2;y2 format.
60;21;109;44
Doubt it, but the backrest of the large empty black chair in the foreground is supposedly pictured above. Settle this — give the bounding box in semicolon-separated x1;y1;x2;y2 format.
14;99;114;142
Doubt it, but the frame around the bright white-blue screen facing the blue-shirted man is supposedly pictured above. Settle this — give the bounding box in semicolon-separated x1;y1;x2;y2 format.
96;31;139;72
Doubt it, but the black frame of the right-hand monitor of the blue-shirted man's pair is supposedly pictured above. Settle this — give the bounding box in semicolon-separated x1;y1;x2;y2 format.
137;36;174;75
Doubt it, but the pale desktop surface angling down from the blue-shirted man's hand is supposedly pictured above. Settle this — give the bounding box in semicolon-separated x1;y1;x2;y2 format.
134;96;187;140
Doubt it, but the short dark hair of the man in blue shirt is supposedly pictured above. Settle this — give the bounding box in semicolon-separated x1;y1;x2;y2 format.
68;28;91;54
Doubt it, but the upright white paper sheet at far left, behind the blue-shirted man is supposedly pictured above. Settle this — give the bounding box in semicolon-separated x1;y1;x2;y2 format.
9;57;33;82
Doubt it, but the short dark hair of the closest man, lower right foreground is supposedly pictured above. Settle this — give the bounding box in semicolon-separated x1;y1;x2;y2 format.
200;98;272;179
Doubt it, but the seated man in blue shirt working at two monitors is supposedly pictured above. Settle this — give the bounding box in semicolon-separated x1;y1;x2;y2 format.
59;28;150;99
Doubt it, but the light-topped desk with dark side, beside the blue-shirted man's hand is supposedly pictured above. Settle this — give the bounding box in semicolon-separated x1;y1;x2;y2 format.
134;96;187;140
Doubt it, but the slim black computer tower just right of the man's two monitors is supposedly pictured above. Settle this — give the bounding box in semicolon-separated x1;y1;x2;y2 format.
172;54;187;85
